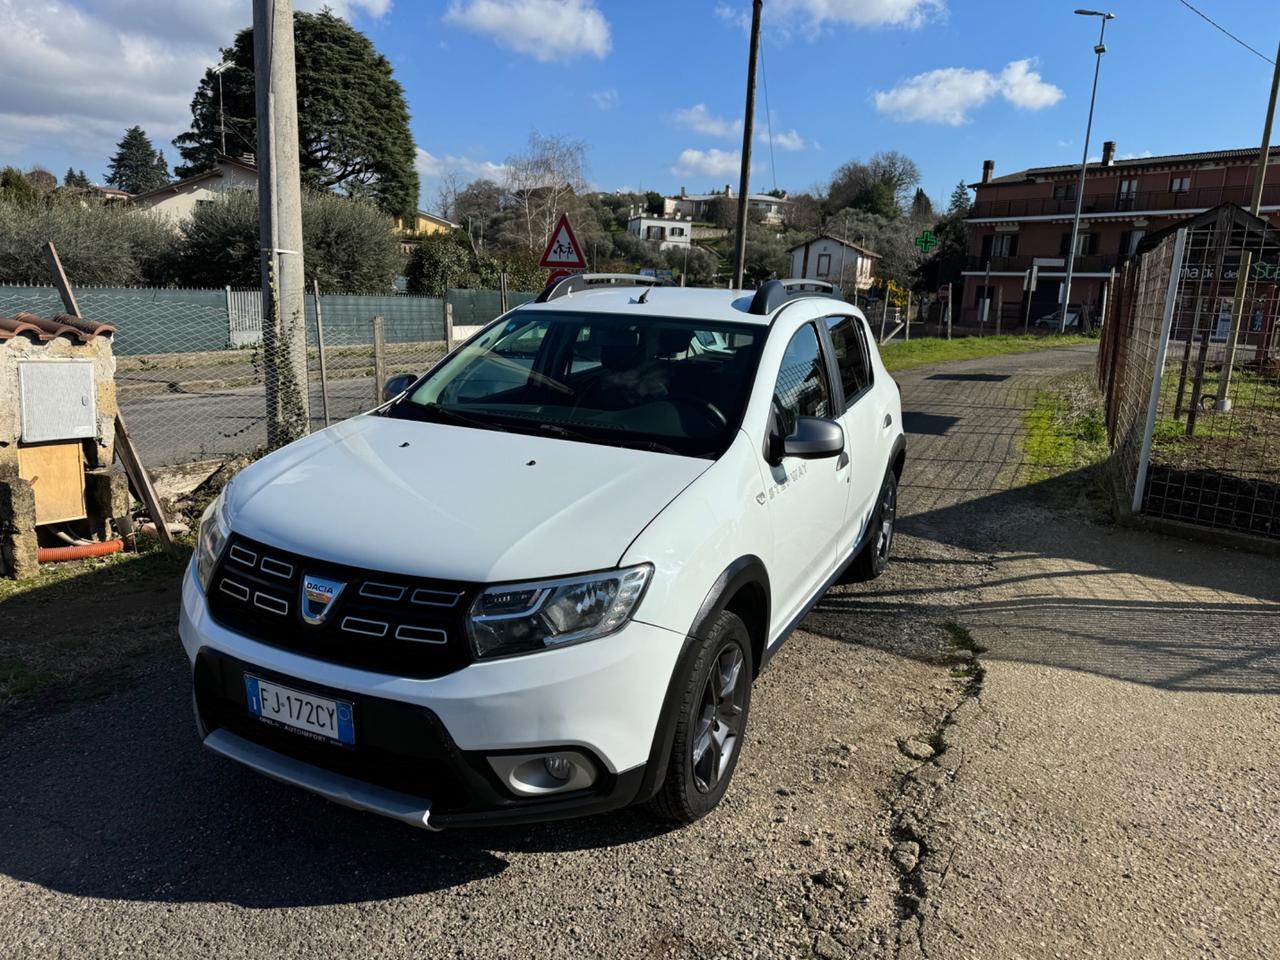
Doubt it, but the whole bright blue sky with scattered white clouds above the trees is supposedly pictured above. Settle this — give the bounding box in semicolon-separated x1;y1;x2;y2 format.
0;0;1280;207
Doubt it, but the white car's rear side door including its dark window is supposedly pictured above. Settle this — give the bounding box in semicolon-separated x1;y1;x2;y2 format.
824;315;892;556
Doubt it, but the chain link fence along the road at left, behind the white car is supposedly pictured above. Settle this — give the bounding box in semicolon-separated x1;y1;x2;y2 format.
0;285;536;467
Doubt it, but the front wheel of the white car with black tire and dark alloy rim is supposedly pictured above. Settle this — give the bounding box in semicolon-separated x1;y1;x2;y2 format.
650;611;754;824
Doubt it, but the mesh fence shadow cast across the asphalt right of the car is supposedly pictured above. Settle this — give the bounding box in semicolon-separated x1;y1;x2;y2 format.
804;472;1280;694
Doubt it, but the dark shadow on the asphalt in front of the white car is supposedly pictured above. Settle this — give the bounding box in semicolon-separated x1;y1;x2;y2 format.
0;655;671;909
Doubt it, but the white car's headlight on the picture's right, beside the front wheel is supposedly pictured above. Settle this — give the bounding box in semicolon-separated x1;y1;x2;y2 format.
467;563;653;658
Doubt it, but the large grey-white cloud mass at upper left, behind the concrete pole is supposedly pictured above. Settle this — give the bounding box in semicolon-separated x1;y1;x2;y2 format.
0;0;390;179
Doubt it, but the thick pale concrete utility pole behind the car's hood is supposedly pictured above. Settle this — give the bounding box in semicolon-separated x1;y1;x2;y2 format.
253;0;310;449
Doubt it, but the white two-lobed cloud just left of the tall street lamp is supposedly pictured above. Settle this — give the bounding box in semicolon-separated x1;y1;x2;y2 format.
873;60;1065;127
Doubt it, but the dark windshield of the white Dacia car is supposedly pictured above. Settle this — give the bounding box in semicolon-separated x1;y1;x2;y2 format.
388;310;765;457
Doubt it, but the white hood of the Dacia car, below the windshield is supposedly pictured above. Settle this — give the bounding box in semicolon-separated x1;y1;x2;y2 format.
228;416;712;581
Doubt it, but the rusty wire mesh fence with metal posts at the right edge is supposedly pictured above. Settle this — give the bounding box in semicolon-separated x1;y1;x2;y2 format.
1098;206;1280;540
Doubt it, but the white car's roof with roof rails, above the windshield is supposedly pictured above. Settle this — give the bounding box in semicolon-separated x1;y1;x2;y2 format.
506;284;851;326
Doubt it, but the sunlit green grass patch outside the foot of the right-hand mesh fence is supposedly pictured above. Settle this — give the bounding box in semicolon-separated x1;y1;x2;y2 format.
1021;374;1110;483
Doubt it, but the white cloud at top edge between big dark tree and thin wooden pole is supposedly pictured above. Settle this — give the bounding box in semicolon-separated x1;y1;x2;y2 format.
444;0;612;63
